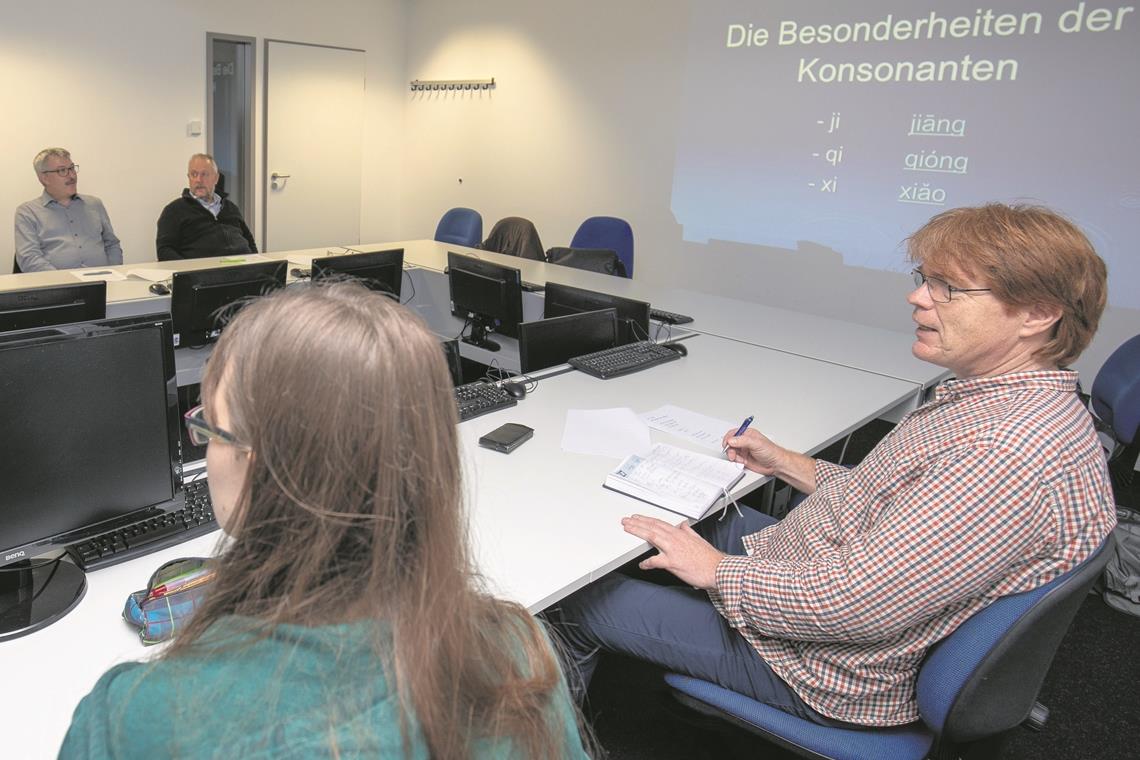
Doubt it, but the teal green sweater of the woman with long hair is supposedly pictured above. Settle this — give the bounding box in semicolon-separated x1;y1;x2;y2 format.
59;619;586;760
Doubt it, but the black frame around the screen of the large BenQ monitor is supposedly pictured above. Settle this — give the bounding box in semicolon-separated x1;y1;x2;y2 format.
0;312;182;567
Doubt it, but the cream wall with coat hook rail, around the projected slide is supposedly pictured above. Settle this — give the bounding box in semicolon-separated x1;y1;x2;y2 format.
401;0;1140;383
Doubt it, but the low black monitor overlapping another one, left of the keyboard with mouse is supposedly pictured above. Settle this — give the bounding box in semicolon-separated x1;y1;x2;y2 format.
519;309;618;374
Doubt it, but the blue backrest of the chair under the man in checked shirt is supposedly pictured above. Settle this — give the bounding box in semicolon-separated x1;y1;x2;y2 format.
917;533;1113;744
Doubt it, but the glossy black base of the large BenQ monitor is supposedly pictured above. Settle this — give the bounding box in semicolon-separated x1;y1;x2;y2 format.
0;550;87;641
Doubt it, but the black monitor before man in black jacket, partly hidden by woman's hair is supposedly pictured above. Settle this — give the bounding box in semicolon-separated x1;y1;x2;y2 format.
170;261;288;346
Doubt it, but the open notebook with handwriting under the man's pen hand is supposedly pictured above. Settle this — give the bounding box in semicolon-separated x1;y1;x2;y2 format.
603;443;744;520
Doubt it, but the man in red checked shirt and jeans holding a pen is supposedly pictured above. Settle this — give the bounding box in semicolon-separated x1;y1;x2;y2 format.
553;204;1116;726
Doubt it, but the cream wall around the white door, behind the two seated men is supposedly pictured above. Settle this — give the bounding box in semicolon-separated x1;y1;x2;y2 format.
0;0;406;271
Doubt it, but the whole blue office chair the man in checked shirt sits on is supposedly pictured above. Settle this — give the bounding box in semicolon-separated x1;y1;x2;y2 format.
665;534;1113;760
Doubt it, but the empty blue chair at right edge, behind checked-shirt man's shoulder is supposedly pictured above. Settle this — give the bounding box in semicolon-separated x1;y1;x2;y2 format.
1089;335;1140;494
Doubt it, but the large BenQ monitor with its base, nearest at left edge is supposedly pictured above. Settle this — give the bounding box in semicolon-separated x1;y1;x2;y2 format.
0;313;181;640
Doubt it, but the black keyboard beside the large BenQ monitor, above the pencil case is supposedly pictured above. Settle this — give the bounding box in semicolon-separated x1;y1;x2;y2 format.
67;477;218;570
